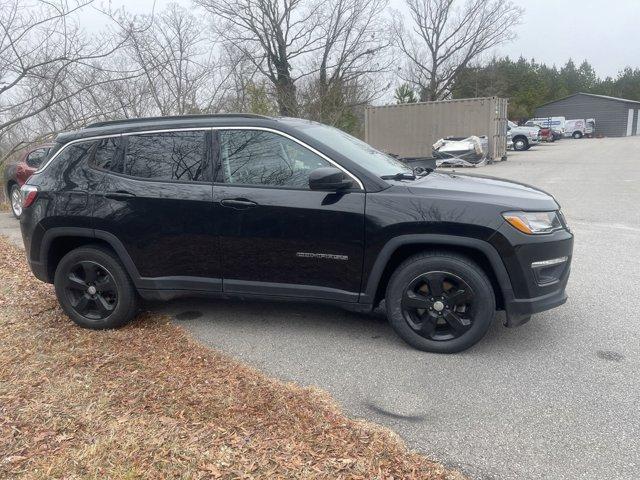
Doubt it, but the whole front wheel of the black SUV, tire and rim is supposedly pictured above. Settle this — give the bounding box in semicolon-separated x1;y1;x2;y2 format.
385;251;496;353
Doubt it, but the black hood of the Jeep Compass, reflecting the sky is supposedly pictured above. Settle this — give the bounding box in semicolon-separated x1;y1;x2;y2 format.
403;172;560;211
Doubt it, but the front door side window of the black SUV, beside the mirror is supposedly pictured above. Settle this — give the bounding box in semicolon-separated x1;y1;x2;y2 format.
218;130;331;188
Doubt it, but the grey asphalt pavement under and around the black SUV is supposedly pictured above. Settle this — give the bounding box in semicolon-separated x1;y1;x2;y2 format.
0;137;640;480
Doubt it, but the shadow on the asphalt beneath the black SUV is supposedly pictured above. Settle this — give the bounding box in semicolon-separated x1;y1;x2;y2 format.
143;298;555;355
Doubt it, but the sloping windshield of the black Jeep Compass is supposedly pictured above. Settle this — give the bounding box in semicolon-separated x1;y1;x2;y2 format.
296;122;413;177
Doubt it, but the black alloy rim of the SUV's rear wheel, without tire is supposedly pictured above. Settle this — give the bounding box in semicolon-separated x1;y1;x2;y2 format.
64;260;118;320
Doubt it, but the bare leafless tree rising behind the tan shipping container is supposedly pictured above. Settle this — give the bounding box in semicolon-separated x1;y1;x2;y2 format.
394;0;522;101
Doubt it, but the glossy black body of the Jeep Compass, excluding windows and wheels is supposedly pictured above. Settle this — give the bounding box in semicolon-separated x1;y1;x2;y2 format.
21;115;573;332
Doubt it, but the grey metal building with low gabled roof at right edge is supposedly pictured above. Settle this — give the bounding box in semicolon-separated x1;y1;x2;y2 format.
536;93;640;137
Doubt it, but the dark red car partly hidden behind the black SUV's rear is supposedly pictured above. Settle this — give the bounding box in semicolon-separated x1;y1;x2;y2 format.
2;144;51;218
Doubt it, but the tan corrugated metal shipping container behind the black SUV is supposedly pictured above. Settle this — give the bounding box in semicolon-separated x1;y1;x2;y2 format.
364;97;507;160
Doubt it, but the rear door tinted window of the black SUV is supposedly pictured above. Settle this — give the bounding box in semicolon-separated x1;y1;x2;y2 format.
124;132;206;181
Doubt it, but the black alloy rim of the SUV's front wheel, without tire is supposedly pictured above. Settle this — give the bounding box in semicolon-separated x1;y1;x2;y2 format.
402;271;475;341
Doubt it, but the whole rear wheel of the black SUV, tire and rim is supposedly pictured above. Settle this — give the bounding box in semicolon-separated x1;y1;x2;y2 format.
54;245;137;330
